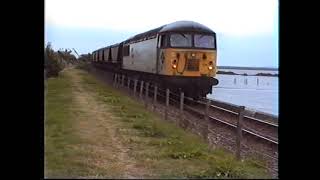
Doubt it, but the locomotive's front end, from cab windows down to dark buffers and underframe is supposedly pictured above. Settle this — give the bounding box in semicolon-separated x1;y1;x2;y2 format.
159;30;218;97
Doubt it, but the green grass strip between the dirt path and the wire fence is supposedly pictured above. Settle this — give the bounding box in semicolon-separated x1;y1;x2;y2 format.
78;68;271;178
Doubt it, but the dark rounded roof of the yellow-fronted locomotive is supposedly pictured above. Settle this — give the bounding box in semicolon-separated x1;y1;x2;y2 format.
124;21;215;43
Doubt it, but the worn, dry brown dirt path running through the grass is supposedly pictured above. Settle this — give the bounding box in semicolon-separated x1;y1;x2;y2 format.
68;70;145;178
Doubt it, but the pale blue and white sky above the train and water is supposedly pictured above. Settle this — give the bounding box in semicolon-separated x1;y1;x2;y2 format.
45;0;279;67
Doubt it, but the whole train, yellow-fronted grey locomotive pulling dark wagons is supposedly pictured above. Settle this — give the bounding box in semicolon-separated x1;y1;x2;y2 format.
92;21;219;99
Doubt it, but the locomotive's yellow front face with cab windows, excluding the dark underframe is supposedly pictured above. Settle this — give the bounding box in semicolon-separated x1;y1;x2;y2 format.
160;32;217;77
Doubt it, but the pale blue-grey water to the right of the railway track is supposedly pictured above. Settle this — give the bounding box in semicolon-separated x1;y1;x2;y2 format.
207;70;279;115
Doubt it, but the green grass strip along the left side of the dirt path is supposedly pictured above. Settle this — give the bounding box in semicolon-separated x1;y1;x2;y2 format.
45;74;81;177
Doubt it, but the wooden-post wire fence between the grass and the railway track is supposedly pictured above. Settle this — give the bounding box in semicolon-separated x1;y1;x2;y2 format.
113;74;278;176
